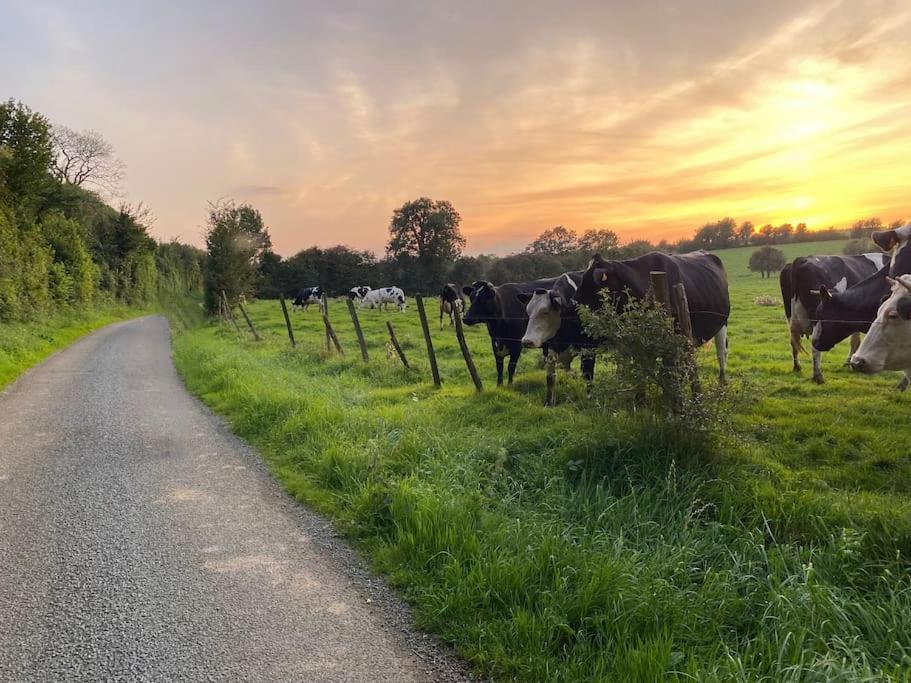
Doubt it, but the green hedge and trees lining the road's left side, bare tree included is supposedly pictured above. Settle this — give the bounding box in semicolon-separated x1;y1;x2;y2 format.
0;99;205;321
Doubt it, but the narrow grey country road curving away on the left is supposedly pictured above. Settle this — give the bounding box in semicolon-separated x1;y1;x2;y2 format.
0;317;463;682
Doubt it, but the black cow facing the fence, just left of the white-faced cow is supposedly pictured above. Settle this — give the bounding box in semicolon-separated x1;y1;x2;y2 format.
462;278;557;386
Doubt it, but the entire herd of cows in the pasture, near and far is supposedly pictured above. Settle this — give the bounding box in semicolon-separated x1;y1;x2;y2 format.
293;223;911;398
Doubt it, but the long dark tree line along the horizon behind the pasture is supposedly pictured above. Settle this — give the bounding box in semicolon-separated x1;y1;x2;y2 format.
246;197;900;298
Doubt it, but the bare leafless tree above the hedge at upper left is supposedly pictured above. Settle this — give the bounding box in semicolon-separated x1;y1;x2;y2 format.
53;126;125;197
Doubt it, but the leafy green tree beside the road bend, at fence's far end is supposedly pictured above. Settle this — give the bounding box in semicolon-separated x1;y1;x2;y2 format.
205;200;272;313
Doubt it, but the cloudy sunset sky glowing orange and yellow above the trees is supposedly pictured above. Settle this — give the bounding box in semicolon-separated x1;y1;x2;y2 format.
0;0;911;256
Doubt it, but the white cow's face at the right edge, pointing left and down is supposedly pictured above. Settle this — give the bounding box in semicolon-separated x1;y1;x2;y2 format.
851;275;911;373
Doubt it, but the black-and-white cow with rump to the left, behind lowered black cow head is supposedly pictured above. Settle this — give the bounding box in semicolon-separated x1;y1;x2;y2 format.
779;254;889;384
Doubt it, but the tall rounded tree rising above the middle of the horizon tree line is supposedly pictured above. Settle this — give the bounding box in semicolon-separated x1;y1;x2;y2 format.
386;197;465;290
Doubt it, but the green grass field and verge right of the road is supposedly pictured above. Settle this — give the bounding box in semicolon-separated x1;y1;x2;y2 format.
174;242;911;681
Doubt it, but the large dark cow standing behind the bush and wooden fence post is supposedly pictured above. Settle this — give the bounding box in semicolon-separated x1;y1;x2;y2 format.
573;251;731;381
